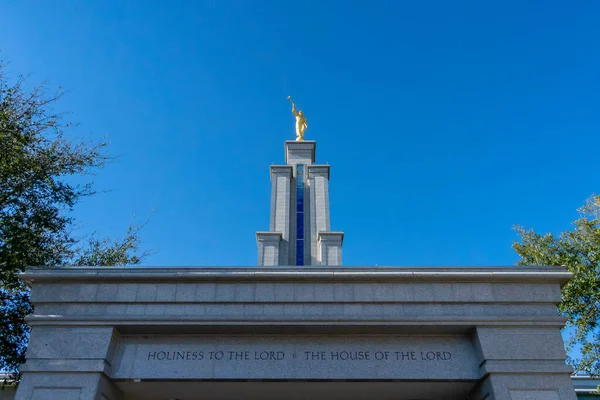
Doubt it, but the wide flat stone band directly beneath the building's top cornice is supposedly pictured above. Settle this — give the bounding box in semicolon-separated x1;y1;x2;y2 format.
27;280;560;304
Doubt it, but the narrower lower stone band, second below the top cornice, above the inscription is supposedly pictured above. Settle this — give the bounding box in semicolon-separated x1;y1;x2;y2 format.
34;302;557;320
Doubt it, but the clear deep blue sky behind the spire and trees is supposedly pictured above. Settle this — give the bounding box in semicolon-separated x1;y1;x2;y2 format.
0;0;600;266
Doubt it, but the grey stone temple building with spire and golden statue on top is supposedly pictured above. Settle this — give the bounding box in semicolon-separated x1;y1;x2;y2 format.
7;132;594;400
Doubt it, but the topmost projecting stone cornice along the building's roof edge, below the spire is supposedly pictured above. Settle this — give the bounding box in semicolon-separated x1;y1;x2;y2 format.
21;267;572;285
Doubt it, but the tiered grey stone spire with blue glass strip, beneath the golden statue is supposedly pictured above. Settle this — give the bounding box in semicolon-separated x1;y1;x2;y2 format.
256;140;344;267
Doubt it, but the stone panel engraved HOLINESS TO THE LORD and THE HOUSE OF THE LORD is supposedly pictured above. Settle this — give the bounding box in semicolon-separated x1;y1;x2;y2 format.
113;335;480;380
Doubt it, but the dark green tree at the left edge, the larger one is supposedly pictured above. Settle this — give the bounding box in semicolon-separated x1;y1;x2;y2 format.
0;64;145;378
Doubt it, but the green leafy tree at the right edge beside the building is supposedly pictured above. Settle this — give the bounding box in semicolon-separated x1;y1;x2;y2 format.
513;195;600;376
